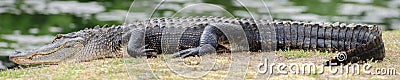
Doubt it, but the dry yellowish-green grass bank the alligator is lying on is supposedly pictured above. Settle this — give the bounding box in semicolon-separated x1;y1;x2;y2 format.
0;31;400;80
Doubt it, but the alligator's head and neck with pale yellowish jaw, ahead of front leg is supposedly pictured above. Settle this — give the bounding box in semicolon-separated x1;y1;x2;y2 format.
10;27;122;65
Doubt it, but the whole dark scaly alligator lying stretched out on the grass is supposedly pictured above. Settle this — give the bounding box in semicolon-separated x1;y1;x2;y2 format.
9;17;385;65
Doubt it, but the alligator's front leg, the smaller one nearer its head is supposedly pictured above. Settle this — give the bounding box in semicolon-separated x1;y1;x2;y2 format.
126;29;156;57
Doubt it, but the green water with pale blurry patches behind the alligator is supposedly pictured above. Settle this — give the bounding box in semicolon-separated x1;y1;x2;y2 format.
0;0;400;68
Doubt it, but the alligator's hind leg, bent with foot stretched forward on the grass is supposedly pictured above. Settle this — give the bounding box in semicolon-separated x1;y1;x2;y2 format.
172;25;222;57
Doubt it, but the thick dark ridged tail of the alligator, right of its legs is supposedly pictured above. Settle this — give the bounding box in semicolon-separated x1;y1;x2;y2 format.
274;22;385;63
